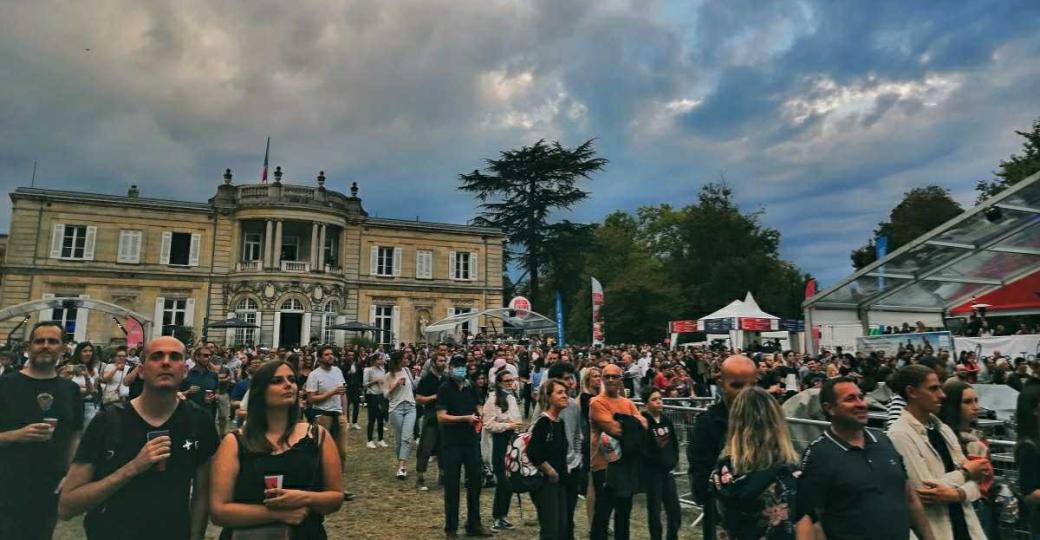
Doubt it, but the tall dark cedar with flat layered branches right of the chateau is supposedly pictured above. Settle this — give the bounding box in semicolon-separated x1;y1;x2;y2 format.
459;139;607;297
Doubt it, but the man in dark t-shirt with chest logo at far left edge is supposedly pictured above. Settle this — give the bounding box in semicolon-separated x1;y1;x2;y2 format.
0;320;83;540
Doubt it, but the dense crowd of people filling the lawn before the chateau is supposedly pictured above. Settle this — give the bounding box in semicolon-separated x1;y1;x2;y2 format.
6;322;1040;540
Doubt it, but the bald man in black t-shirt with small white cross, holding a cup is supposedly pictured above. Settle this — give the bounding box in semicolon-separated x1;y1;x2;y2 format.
58;336;217;540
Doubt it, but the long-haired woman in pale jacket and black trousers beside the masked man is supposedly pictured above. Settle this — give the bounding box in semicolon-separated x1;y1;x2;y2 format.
482;369;523;531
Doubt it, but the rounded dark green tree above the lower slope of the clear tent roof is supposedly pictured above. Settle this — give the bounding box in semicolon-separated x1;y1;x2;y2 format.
851;185;964;269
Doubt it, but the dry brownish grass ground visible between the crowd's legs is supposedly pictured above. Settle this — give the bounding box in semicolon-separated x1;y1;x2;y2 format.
55;411;700;540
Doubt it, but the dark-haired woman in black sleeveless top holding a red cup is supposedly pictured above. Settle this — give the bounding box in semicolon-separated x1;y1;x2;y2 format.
209;361;343;540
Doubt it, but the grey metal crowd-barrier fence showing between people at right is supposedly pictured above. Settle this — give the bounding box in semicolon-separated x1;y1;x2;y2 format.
664;398;1030;540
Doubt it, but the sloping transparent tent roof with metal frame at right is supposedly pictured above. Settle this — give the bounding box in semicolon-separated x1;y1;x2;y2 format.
803;173;1040;312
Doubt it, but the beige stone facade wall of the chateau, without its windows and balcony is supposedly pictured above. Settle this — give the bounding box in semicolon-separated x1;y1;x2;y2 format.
0;188;502;344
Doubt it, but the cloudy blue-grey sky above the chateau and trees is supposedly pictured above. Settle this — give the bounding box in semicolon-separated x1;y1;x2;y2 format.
0;0;1040;284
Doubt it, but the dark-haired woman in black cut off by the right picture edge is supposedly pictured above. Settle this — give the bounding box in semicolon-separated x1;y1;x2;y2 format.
1015;383;1040;539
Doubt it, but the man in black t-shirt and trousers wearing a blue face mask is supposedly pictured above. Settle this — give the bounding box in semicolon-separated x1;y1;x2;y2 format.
437;355;493;538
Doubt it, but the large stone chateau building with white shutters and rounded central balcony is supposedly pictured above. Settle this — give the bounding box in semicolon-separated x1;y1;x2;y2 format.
0;168;504;346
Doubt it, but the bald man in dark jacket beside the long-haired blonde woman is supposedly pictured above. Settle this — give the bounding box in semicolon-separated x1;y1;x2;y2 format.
686;355;758;540
